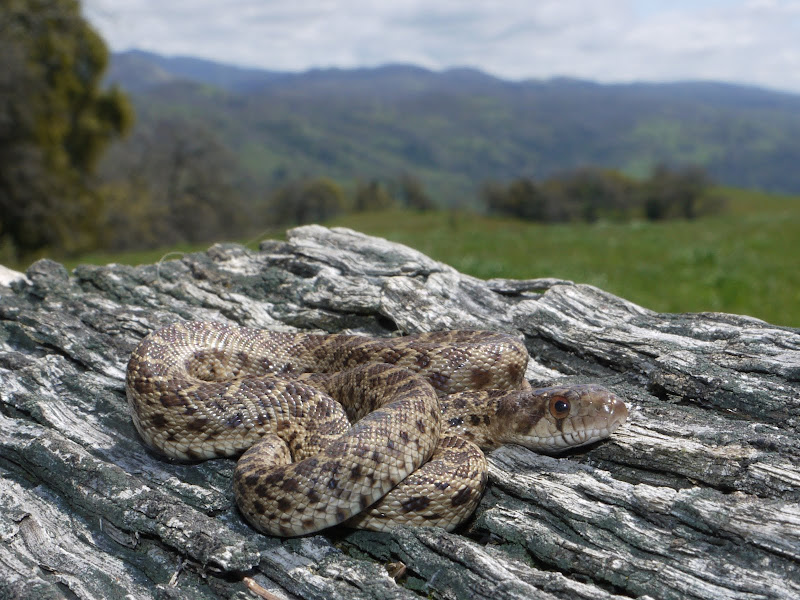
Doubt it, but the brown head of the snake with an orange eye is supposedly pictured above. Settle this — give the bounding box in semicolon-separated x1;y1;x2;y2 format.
495;385;628;451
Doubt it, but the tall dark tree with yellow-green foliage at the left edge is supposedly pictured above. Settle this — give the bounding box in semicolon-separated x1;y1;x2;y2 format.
0;0;133;254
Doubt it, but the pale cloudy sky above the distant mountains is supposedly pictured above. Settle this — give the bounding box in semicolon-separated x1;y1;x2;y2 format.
83;0;800;93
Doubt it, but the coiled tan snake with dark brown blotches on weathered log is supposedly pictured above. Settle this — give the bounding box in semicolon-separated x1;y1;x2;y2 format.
125;321;628;537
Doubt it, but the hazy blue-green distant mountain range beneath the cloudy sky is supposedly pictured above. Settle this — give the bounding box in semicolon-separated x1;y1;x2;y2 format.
107;51;800;199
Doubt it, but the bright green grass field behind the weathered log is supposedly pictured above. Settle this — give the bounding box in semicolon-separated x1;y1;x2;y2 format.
57;190;800;327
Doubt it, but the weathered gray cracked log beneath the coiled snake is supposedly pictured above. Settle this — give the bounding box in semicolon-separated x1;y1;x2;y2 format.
0;226;800;600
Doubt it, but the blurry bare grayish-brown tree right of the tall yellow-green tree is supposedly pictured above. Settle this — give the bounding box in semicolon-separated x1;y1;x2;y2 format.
100;118;253;249
